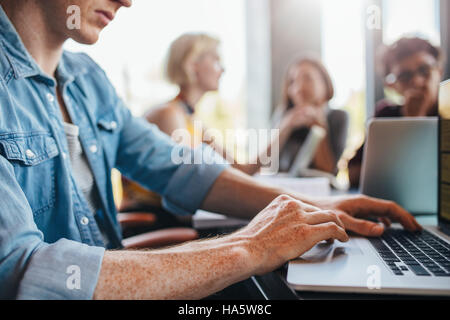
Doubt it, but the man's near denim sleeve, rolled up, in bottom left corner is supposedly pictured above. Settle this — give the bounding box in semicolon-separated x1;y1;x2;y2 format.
0;156;104;299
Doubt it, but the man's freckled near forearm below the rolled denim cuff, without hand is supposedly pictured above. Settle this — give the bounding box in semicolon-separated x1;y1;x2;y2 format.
94;236;256;299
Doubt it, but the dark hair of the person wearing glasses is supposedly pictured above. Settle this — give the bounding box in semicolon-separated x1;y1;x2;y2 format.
378;37;444;77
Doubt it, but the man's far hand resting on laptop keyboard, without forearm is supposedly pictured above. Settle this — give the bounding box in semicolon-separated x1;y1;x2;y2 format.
315;195;422;237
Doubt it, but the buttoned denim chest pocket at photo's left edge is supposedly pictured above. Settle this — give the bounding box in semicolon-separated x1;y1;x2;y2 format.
0;133;59;217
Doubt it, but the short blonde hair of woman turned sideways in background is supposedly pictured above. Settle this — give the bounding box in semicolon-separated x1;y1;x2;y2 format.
166;33;220;86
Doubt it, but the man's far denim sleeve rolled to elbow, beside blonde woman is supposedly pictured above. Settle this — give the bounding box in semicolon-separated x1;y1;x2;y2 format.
116;102;229;215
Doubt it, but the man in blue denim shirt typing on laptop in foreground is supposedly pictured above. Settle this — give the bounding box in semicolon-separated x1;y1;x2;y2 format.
0;0;420;299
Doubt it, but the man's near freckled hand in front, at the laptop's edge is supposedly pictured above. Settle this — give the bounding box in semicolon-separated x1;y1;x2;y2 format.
232;195;348;274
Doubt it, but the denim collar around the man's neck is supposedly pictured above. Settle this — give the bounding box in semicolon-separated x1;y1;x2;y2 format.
0;5;86;82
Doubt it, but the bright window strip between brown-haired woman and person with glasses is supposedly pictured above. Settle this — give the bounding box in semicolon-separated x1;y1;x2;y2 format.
321;0;366;176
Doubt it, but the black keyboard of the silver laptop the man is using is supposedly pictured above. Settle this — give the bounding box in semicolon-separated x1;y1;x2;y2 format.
369;229;450;277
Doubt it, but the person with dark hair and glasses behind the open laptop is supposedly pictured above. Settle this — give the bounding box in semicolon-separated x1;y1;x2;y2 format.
348;38;444;187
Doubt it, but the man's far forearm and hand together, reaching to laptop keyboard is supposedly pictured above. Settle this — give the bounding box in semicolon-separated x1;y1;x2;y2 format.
202;169;421;237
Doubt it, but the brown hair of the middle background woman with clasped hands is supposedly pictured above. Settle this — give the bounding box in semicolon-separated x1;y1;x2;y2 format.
281;56;334;109
